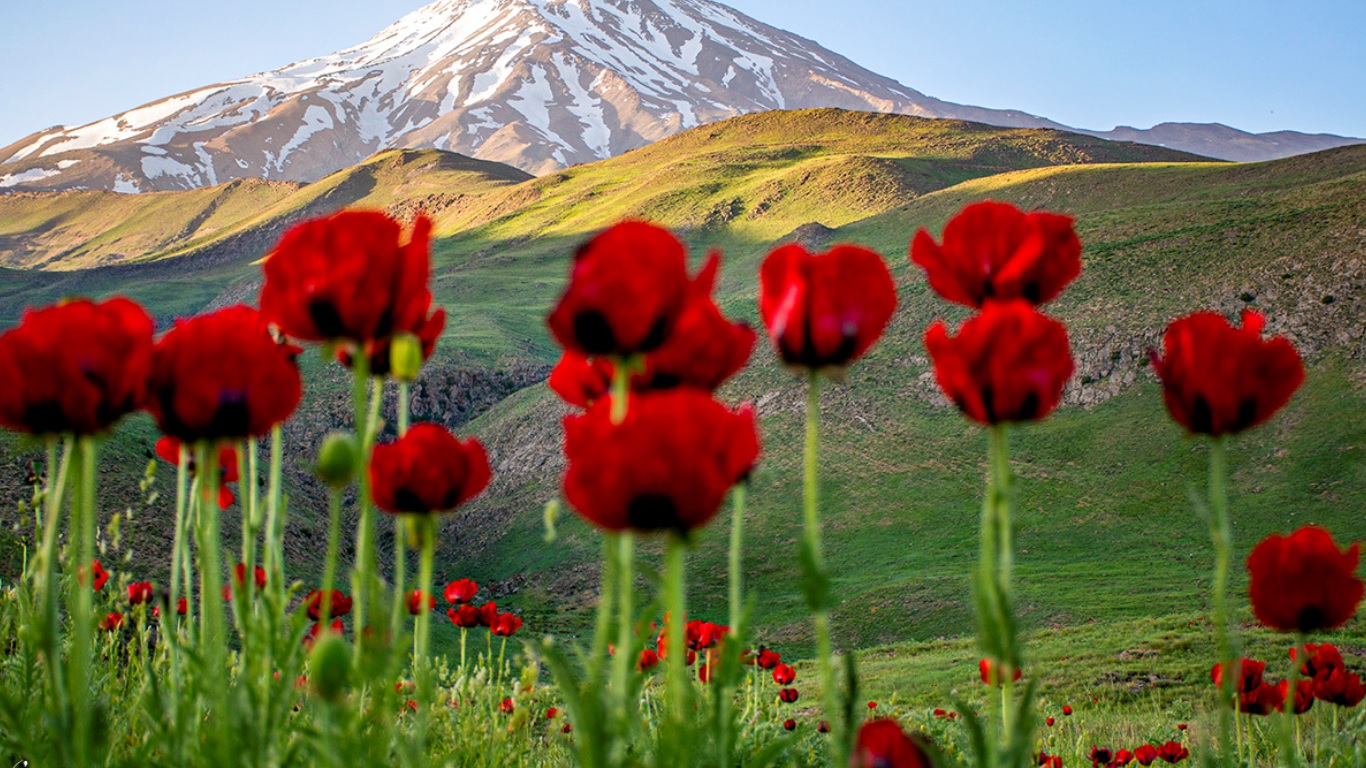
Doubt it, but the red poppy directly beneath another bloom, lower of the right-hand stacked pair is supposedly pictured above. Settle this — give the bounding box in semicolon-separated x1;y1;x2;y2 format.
925;301;1072;425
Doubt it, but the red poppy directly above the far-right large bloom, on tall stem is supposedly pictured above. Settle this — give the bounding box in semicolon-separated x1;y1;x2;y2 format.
1149;310;1305;436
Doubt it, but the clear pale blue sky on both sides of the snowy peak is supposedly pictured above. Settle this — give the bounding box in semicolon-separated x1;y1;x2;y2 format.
0;0;1366;146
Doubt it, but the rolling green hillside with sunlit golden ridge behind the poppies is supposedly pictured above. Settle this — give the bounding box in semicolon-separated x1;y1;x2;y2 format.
0;111;1366;669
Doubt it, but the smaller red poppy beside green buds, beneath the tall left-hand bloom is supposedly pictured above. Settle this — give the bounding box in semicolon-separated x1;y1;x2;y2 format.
370;424;492;514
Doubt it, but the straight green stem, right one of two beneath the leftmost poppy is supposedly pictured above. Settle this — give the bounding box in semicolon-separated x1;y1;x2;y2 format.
68;436;98;765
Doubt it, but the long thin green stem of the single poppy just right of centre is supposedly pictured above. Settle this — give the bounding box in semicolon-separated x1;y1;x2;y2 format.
803;370;852;768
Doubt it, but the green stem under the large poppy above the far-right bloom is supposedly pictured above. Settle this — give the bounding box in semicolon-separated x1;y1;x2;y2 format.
1209;437;1242;765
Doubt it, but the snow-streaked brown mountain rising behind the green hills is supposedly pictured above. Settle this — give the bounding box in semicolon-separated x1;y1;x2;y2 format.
0;0;1355;193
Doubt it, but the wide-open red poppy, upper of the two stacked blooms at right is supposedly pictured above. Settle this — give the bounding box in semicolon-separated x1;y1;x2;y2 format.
911;201;1082;307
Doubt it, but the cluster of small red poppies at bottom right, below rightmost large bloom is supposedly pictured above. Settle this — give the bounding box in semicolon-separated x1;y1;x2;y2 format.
1209;642;1366;716
